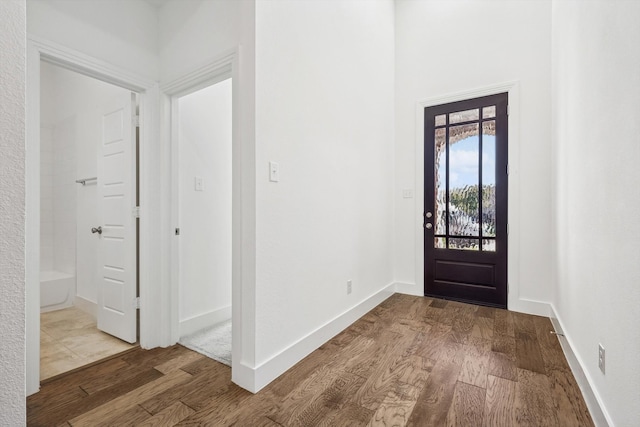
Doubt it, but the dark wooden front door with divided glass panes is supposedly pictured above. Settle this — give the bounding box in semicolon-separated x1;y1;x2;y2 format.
423;93;508;308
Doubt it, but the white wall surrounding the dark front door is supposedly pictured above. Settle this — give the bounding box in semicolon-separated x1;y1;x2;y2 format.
394;0;552;310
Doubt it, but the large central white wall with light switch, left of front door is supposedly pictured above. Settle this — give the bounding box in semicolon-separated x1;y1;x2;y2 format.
255;1;394;366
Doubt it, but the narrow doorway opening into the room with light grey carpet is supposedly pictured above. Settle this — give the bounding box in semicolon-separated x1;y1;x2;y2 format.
172;78;233;366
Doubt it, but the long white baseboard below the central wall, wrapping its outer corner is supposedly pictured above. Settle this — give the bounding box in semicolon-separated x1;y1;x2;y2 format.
232;283;395;393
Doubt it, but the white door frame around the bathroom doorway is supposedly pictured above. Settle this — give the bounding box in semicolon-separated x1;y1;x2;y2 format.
25;35;162;395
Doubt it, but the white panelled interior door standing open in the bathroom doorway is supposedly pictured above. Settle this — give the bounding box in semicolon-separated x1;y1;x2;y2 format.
98;93;137;343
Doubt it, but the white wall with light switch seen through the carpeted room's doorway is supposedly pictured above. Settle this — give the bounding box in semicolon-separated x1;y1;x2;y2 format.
178;79;232;334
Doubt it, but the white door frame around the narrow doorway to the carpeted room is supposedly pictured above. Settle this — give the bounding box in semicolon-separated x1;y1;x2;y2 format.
161;49;243;371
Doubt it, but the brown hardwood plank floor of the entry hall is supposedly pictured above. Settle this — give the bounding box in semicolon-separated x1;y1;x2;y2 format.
27;294;593;427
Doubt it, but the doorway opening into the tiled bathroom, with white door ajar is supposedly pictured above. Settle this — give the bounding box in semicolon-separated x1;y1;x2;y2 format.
39;61;138;381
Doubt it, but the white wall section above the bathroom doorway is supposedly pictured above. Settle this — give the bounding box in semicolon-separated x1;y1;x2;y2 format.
27;0;158;79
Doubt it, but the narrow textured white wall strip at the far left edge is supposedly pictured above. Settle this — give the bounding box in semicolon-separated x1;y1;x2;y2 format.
0;0;26;426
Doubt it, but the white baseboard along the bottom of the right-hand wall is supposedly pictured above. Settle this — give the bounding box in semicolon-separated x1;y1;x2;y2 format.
549;304;613;427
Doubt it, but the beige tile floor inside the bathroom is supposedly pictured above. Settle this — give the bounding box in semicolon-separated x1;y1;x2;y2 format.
40;307;137;381
